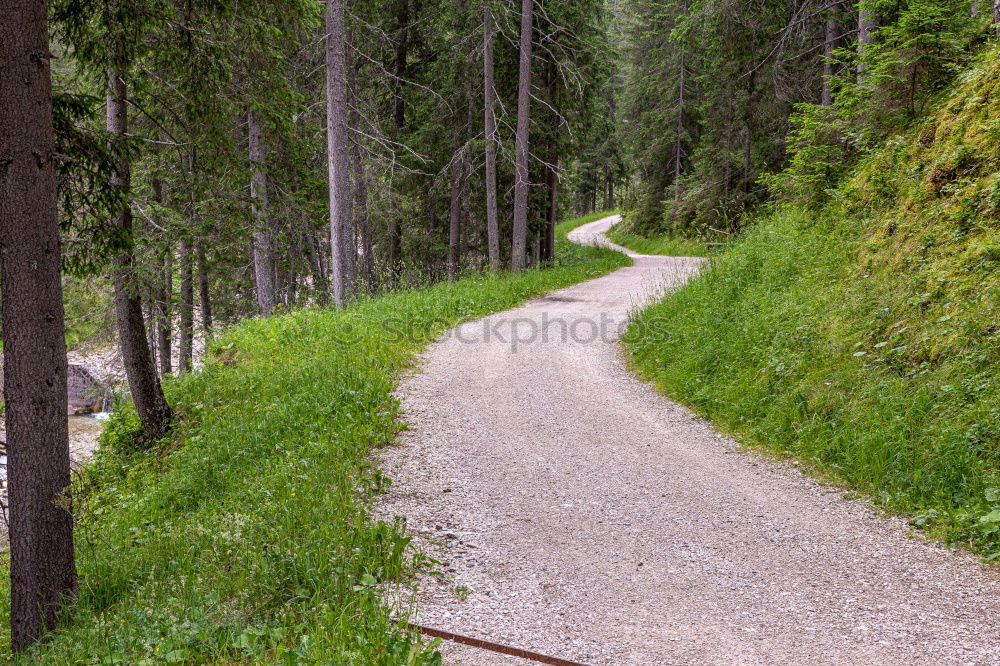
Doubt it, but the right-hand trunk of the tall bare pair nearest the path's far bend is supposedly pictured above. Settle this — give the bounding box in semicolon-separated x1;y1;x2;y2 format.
510;0;534;272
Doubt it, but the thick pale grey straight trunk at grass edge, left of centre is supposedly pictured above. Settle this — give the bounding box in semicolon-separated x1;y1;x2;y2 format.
326;0;351;307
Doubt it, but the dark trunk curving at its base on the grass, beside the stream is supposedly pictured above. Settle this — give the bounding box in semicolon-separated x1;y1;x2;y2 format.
107;71;170;442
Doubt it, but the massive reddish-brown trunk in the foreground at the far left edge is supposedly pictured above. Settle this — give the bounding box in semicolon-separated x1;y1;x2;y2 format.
0;0;76;652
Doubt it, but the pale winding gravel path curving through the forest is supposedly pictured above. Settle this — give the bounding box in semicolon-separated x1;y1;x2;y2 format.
380;218;1000;666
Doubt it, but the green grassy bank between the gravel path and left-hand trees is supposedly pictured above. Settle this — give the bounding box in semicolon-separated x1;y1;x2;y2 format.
0;215;627;666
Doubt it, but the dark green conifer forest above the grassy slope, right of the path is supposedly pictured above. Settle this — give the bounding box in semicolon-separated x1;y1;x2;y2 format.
621;1;998;235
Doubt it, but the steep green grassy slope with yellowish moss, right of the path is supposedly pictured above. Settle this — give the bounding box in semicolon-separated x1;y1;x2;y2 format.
630;48;1000;558
